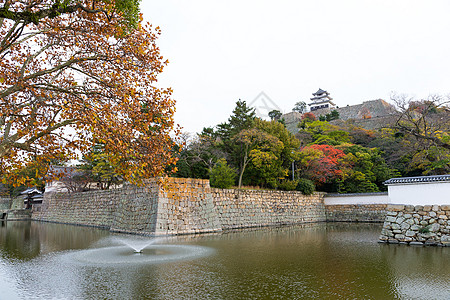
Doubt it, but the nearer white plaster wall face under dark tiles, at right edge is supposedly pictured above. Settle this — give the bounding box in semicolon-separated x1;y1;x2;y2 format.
388;182;450;205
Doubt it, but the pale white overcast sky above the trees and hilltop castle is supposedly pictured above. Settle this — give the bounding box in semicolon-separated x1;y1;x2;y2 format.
141;0;450;133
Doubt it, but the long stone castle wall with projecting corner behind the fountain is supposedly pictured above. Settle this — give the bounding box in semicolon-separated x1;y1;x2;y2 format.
32;178;326;235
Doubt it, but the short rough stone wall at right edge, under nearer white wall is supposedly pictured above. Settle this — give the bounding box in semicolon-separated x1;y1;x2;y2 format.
380;205;450;246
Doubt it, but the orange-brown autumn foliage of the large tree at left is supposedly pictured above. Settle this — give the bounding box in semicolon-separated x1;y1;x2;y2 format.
0;2;179;184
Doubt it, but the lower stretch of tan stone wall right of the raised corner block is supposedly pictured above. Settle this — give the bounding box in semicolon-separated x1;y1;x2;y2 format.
211;189;326;229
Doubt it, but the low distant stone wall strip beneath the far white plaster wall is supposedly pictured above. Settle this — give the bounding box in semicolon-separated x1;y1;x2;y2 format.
325;204;388;223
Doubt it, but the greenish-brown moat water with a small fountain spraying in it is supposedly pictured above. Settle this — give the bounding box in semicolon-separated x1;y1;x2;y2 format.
0;221;450;299
